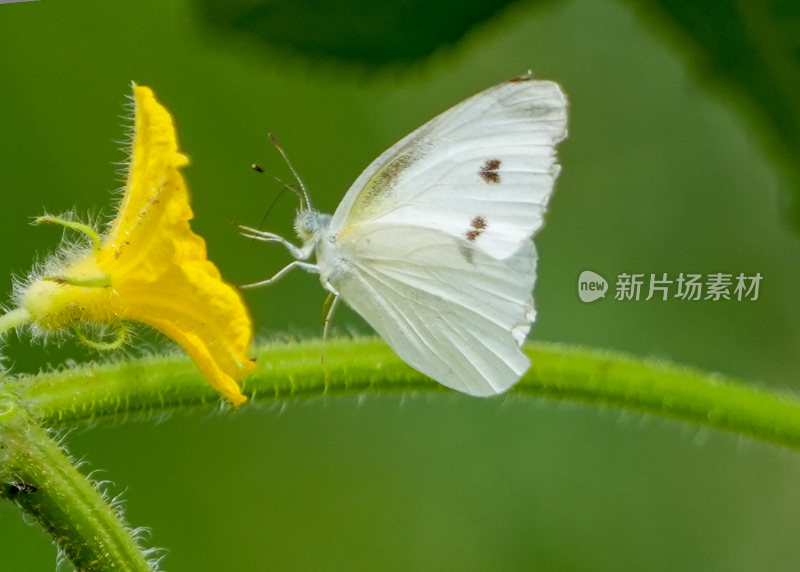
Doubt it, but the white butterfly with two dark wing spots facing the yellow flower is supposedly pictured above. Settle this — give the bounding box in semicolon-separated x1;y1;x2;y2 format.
244;76;567;396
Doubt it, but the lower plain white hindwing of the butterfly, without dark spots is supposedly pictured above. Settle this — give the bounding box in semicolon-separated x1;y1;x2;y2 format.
319;223;536;396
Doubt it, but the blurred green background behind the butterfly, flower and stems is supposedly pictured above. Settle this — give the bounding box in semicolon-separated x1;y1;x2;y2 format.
0;0;800;571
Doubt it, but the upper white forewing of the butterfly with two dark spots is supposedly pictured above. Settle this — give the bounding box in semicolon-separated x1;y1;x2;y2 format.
330;77;566;258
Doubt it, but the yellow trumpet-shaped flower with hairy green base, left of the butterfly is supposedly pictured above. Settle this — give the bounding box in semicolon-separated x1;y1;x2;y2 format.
19;86;254;405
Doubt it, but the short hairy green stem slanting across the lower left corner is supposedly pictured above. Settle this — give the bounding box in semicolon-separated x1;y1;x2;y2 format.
0;397;152;571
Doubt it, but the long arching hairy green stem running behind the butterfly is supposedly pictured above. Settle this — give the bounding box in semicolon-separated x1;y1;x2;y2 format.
9;339;800;449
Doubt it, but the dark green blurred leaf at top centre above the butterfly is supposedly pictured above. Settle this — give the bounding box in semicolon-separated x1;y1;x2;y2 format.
192;0;512;67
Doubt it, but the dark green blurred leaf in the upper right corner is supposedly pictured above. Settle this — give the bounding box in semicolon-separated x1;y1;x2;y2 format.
641;0;800;230
